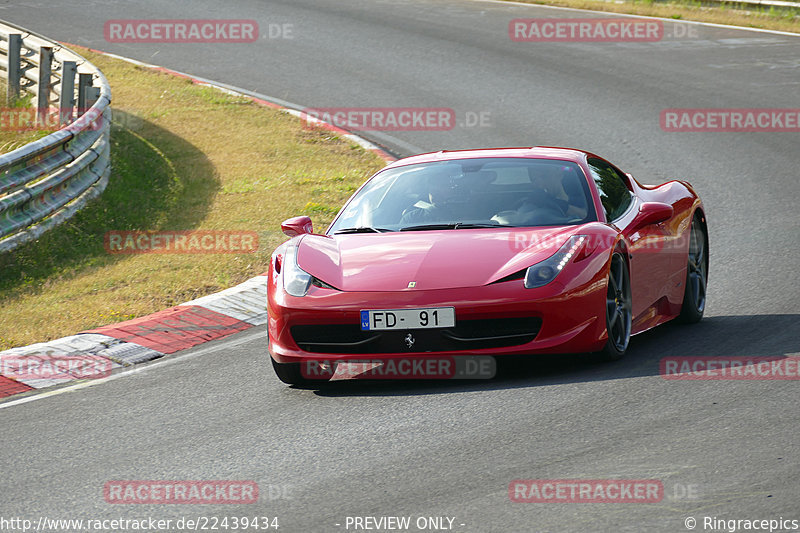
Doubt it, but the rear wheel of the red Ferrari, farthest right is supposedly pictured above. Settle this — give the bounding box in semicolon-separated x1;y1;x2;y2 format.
678;214;708;324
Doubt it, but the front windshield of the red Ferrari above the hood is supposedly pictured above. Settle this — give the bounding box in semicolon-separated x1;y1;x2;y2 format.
328;158;597;233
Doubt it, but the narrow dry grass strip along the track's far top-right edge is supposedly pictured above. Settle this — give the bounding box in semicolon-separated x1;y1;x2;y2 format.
500;0;800;33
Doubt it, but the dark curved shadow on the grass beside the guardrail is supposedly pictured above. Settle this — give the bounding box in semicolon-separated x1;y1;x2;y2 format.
0;110;219;300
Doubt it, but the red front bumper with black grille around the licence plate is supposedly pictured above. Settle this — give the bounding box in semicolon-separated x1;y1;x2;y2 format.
268;268;606;363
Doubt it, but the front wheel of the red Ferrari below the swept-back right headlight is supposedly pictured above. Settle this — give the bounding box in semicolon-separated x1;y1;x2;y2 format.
600;252;632;361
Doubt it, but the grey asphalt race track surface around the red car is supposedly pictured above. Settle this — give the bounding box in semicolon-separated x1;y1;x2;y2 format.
0;0;800;532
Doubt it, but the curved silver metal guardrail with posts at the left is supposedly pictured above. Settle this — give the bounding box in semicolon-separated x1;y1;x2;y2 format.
0;21;111;253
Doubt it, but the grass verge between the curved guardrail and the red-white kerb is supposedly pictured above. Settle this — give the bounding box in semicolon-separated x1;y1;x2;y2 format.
0;51;384;349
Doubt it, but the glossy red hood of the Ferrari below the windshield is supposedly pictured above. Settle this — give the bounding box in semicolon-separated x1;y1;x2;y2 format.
297;226;580;291
